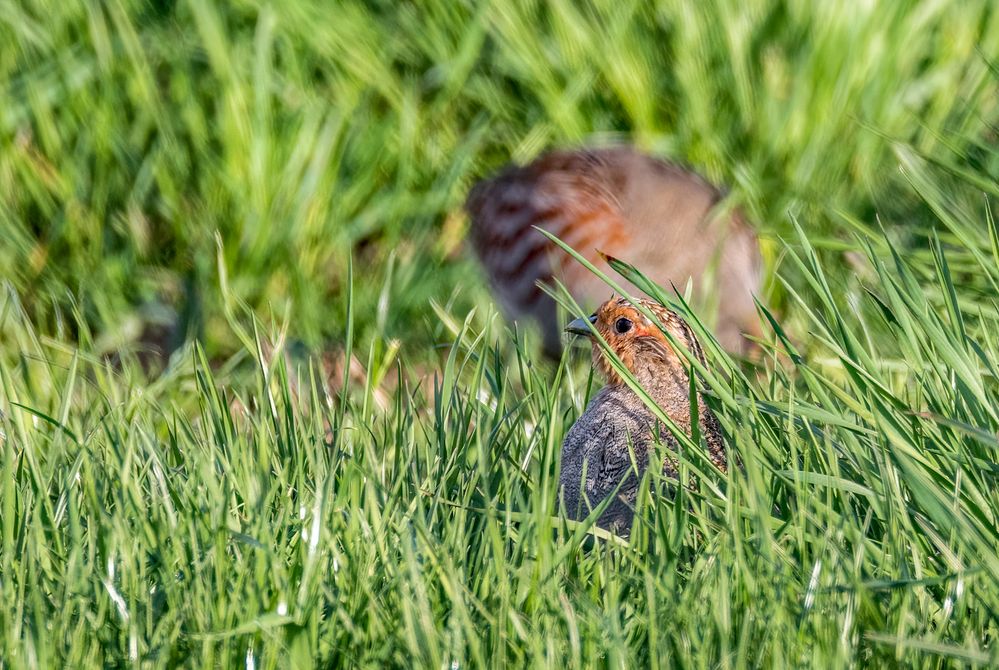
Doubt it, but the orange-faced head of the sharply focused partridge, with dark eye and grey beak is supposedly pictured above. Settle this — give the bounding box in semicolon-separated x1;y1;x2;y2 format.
565;298;704;386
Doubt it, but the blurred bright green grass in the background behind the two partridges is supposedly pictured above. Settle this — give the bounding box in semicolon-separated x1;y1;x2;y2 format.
0;0;999;355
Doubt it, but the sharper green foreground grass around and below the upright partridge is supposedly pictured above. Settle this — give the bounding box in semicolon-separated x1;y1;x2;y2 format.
0;184;999;667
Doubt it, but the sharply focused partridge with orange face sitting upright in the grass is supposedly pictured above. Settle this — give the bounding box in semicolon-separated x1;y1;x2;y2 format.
559;297;728;536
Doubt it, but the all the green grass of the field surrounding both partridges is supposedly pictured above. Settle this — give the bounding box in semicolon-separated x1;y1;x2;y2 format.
0;0;999;669
